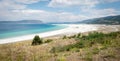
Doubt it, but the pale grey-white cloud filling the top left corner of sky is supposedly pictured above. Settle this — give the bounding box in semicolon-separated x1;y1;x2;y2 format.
0;0;47;10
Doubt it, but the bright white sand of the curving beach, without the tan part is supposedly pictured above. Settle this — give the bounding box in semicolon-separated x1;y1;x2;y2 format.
0;24;108;44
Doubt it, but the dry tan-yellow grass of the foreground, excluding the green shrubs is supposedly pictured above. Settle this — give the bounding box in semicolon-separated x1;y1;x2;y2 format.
0;31;120;61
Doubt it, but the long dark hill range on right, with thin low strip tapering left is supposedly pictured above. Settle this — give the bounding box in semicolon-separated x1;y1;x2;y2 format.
50;15;120;25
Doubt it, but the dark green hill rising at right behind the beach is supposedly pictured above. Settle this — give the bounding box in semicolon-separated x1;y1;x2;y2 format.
75;15;120;25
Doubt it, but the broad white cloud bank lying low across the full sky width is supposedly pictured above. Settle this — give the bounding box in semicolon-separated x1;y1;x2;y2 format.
0;9;118;22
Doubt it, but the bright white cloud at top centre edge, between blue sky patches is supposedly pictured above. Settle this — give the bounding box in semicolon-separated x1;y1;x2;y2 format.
48;0;98;7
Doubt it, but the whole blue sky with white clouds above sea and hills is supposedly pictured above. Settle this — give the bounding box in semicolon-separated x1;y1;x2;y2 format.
0;0;120;22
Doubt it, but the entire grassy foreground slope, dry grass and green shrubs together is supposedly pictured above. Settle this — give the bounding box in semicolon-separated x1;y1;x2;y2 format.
0;32;120;61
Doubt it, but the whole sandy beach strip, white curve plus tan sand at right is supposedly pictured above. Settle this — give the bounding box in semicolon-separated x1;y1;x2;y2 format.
0;24;120;44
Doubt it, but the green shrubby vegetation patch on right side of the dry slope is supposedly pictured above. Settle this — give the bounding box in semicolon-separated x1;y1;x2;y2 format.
50;32;120;53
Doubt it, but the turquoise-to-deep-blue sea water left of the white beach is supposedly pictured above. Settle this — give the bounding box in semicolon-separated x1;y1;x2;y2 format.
0;24;67;39
